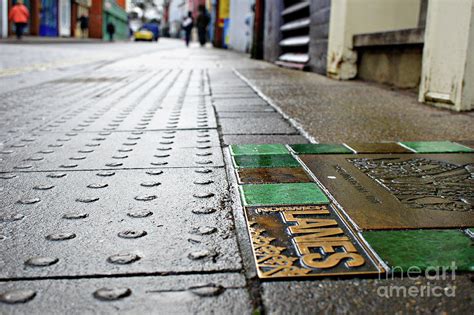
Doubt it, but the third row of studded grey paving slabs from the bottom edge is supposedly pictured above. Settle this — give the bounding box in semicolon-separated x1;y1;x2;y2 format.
0;129;224;171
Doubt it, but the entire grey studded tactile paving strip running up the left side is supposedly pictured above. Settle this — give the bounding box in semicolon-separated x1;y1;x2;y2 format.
0;69;260;313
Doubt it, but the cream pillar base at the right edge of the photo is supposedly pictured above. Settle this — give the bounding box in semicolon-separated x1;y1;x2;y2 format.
419;0;474;110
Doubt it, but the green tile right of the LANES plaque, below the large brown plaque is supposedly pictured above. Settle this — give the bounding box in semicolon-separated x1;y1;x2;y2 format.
362;230;474;272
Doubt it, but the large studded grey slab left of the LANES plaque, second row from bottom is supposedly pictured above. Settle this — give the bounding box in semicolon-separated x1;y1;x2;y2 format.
0;169;241;279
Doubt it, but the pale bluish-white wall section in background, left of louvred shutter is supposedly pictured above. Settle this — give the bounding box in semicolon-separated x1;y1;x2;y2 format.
229;0;254;52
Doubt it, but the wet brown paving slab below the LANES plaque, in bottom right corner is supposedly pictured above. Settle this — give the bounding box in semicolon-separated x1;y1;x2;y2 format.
262;275;474;314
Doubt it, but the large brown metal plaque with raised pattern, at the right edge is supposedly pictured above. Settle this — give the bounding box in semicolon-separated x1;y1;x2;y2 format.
301;153;474;229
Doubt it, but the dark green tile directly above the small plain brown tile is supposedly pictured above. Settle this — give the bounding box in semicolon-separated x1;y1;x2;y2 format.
233;154;301;168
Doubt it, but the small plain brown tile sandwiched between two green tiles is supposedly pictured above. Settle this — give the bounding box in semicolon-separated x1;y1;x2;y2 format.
237;167;311;184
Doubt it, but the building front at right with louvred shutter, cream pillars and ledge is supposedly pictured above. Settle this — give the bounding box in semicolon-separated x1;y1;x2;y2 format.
262;0;474;111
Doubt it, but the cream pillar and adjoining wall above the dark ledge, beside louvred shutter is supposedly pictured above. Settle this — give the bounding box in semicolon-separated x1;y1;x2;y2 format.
328;0;421;79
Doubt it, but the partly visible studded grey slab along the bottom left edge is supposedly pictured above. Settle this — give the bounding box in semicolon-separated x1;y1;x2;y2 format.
0;273;252;314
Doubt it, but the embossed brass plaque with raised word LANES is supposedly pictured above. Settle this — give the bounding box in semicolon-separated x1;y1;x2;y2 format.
245;205;385;279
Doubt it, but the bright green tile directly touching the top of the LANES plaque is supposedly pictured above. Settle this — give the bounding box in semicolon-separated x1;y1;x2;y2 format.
240;183;329;206
